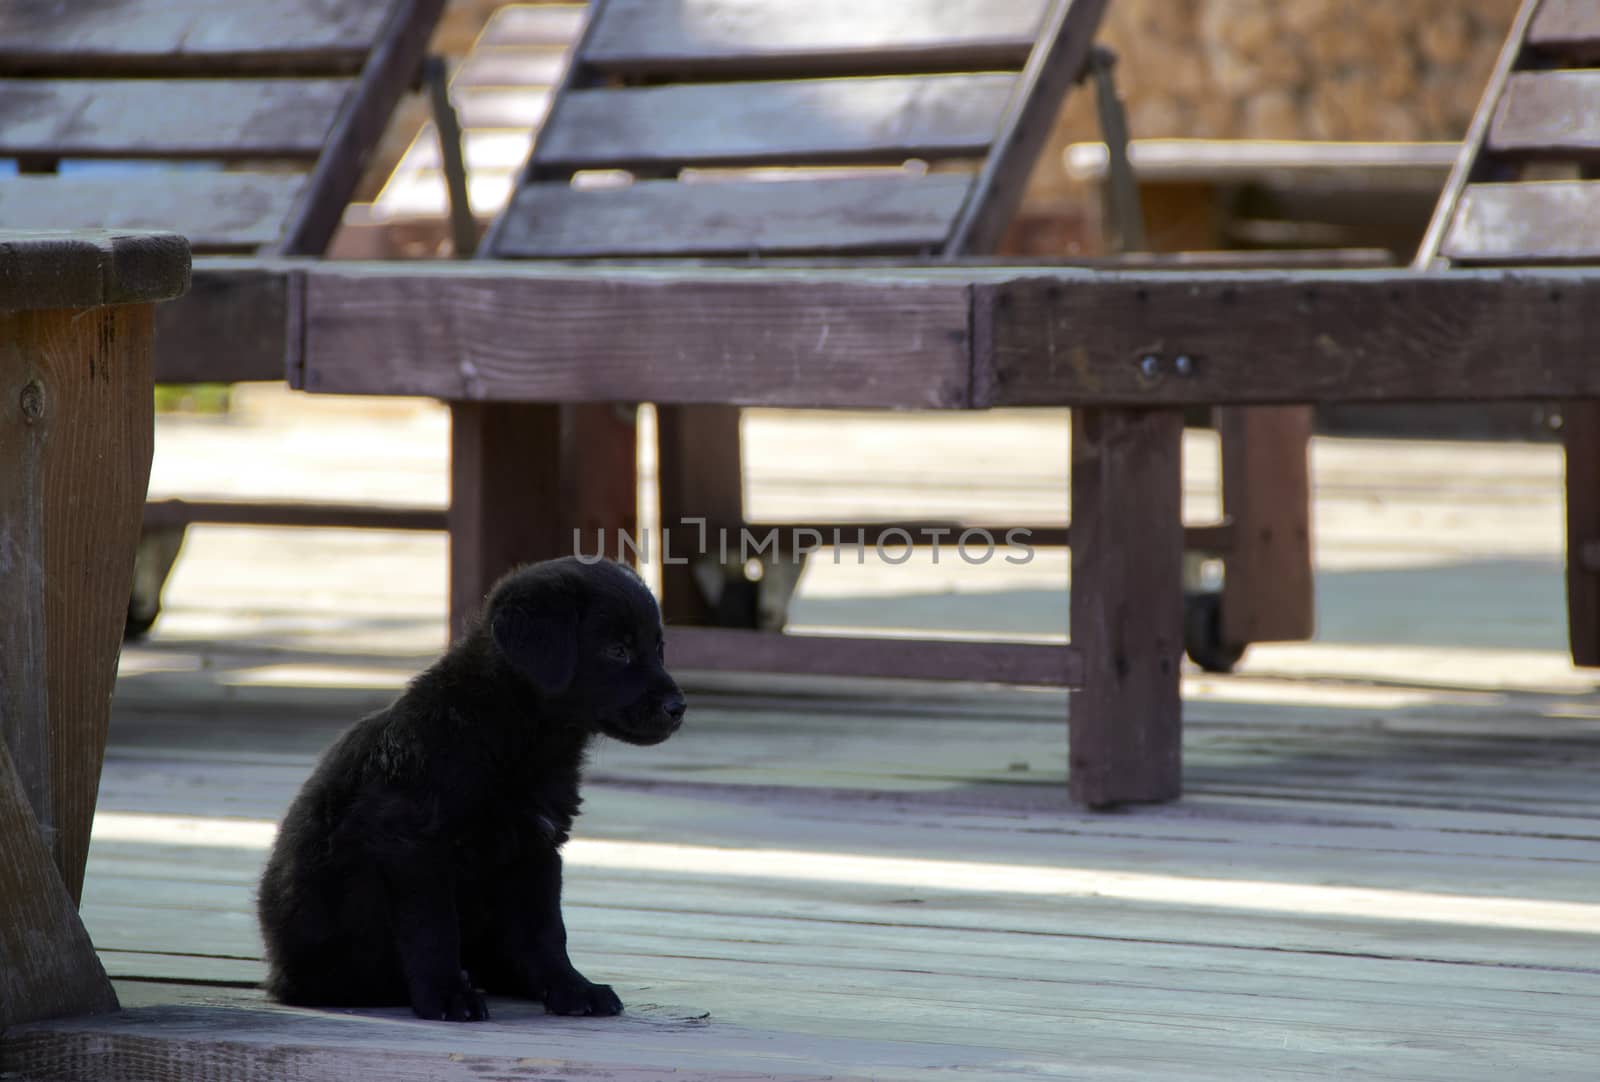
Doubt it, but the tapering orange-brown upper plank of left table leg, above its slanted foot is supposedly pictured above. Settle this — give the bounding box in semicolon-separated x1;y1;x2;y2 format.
0;304;155;901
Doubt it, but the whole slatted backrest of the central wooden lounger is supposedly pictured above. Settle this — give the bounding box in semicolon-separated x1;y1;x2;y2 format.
483;0;1106;259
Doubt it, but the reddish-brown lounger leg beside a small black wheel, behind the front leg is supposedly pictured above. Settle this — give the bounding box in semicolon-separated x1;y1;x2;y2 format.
1216;407;1315;645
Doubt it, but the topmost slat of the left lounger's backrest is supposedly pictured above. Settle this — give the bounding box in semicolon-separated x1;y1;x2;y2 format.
0;0;394;75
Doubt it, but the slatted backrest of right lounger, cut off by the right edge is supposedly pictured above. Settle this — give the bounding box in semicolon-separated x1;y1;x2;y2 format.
1418;0;1600;266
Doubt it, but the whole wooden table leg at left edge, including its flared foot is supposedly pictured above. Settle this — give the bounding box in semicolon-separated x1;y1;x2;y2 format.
0;304;155;1026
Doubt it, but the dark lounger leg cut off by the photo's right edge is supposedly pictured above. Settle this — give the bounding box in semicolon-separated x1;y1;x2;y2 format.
1563;399;1600;667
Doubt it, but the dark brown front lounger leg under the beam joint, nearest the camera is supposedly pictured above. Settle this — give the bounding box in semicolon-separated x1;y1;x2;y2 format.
1069;410;1184;807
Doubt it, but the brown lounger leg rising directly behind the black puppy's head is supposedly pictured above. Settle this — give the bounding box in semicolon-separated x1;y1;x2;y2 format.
450;402;573;639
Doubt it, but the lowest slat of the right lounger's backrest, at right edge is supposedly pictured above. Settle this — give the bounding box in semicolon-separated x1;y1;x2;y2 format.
1443;181;1600;264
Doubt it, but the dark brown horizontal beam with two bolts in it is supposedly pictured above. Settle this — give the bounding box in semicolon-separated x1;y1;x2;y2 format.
973;271;1600;407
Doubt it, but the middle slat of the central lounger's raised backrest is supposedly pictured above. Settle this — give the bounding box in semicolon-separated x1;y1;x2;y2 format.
538;74;1016;170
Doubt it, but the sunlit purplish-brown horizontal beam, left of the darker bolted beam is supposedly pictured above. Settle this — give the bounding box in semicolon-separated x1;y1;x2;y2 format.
296;262;971;410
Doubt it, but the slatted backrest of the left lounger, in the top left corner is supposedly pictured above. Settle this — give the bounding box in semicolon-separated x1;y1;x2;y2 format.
0;0;443;254
